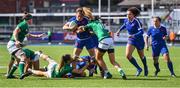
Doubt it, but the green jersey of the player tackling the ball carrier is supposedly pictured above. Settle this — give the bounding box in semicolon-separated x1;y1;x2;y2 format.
85;20;111;41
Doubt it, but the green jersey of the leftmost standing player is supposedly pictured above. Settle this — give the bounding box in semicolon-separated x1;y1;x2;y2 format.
10;20;29;42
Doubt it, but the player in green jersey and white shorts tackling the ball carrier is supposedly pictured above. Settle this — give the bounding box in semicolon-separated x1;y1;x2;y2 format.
77;7;126;79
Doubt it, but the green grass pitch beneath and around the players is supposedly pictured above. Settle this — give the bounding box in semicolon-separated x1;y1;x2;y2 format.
0;45;180;88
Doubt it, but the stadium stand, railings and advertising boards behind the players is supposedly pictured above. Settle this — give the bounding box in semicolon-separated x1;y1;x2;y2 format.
0;0;180;44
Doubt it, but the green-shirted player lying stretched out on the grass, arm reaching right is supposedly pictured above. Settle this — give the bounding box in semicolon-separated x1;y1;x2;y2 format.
23;54;89;78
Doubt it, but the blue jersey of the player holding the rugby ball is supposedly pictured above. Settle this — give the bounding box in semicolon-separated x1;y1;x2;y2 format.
69;16;91;39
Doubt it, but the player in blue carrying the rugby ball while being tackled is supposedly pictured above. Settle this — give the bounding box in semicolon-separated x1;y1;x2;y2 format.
63;8;95;59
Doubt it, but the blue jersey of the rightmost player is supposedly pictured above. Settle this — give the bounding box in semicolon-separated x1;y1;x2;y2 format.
147;26;167;45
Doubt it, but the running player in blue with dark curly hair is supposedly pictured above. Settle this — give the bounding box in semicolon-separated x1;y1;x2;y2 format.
116;7;148;76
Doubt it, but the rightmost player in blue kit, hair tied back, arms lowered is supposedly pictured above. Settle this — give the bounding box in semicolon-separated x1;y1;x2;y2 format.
146;17;176;77
